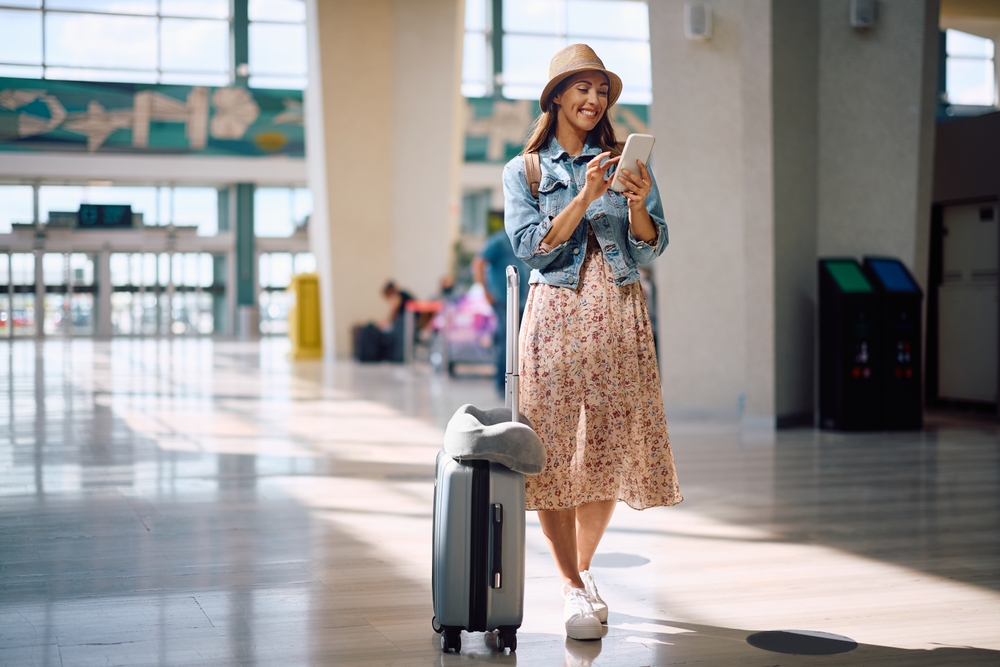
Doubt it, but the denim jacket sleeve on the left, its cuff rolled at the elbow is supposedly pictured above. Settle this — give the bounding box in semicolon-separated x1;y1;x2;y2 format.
503;155;568;270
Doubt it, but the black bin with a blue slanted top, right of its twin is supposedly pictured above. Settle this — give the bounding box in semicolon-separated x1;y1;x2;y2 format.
864;257;924;430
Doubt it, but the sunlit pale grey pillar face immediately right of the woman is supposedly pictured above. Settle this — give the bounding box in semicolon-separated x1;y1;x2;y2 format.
649;0;774;423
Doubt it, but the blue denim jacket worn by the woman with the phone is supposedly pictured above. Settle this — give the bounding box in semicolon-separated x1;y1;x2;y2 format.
503;137;667;288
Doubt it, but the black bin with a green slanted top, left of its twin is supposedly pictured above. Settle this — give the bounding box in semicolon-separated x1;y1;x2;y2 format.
819;258;881;431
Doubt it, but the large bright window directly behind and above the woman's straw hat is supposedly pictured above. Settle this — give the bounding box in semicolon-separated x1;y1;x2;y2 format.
462;0;653;104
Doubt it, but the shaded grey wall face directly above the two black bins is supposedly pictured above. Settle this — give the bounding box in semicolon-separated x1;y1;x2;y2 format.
817;0;938;292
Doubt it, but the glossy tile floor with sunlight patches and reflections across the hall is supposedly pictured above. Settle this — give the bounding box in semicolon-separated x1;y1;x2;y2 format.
0;340;1000;667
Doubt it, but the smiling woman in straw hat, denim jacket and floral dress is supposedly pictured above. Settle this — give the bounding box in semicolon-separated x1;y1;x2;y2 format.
503;44;681;639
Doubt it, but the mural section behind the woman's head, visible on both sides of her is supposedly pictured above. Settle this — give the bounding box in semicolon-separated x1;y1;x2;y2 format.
465;98;649;163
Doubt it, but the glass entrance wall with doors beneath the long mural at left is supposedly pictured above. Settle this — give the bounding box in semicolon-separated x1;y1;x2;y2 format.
0;185;316;337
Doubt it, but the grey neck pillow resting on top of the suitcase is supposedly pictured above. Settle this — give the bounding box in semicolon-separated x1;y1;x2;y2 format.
444;405;545;475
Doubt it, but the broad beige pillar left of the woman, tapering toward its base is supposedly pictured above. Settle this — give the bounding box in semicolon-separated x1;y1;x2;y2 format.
306;0;464;357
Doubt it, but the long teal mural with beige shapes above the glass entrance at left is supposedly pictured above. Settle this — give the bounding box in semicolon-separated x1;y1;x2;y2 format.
0;78;305;157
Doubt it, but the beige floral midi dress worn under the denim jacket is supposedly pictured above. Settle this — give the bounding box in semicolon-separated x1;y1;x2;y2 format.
520;231;682;510
